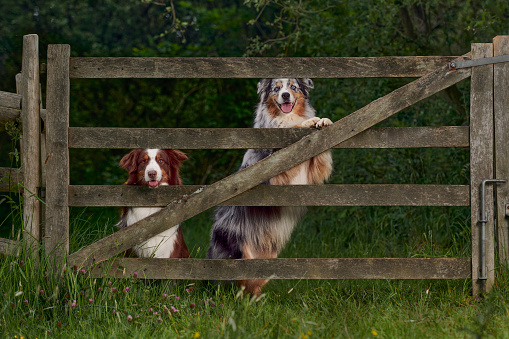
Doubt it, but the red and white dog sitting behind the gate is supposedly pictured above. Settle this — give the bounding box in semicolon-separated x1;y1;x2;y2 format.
116;149;189;258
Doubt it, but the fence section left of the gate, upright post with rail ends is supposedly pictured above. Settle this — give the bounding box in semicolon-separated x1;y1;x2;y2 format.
0;34;43;253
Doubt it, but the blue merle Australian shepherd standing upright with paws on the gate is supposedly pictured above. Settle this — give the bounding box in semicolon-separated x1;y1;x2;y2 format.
207;79;332;294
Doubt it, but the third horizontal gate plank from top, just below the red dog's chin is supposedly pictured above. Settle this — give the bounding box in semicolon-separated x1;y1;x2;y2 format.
69;185;470;207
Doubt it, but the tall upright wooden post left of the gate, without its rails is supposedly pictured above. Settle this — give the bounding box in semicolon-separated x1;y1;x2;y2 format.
21;34;41;252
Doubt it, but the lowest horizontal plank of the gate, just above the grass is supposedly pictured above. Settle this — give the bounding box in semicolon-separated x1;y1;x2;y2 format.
92;258;471;280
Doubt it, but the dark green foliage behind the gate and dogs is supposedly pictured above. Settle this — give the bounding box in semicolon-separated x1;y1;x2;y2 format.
0;0;509;254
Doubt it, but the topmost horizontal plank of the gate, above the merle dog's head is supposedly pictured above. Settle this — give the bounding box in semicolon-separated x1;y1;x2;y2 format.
70;56;457;78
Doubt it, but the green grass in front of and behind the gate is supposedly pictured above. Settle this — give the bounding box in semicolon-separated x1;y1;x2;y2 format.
0;202;509;338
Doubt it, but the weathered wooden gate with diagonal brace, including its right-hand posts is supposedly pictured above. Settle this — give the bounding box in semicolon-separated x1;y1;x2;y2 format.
0;36;509;293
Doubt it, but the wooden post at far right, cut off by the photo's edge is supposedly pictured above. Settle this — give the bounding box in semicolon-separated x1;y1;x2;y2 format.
493;35;509;265
